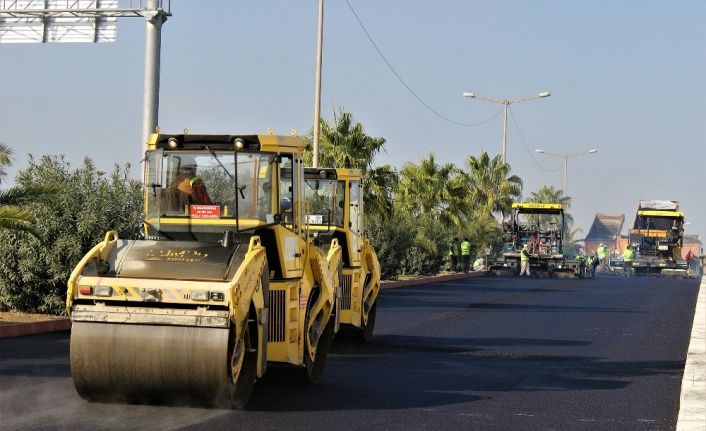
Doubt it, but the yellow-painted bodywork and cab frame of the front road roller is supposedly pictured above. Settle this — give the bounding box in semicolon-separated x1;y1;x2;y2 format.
66;134;341;408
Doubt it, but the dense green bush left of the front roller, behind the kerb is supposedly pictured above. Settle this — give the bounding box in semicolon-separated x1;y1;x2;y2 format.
0;156;142;314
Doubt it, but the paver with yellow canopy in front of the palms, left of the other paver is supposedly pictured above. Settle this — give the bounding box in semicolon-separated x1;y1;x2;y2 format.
489;202;581;277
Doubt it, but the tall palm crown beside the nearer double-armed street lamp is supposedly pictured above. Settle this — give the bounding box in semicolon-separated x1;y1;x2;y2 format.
466;151;522;216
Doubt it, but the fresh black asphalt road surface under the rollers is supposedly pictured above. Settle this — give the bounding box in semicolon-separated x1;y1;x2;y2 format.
0;278;699;431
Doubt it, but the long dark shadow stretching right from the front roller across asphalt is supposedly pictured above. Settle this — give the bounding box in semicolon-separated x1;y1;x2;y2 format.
243;335;684;411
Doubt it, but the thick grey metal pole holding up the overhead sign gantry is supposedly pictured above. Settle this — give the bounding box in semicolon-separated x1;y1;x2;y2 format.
140;0;164;159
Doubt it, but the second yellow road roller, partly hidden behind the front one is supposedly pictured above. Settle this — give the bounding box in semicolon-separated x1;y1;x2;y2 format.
304;168;380;341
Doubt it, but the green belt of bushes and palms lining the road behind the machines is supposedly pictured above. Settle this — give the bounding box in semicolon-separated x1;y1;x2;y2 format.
0;110;580;314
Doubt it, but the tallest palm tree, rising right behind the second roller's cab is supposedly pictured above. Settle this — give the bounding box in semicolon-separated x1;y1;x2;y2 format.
305;110;397;219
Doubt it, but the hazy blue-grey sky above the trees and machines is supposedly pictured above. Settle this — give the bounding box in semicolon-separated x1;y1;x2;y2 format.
0;0;706;238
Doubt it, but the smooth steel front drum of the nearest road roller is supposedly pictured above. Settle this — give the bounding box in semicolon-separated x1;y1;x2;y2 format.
71;322;231;404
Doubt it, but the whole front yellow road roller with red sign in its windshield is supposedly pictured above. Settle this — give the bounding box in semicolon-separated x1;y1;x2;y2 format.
66;134;340;408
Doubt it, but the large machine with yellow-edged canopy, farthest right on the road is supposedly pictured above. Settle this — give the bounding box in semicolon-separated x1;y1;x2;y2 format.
615;200;688;276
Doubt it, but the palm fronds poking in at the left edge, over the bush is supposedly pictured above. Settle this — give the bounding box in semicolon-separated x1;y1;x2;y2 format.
0;143;56;239
